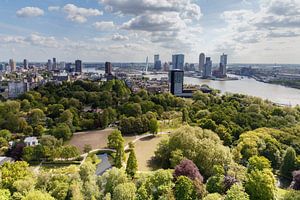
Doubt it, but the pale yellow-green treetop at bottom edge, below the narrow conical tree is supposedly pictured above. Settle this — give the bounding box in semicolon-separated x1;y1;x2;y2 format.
112;183;136;200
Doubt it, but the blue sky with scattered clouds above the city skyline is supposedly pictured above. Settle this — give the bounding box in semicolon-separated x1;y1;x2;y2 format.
0;0;300;64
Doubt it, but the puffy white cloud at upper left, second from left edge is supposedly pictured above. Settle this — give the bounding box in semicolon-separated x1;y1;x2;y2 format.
63;4;103;23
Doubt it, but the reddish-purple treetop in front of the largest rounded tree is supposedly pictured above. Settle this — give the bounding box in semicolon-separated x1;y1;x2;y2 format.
174;159;203;182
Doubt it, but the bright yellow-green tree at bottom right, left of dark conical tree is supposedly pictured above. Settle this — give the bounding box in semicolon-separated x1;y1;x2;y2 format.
245;169;276;200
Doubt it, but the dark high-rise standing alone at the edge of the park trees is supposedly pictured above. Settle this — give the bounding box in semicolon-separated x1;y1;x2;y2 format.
169;69;184;96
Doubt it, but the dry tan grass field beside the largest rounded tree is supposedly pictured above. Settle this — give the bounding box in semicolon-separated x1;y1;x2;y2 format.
135;135;168;171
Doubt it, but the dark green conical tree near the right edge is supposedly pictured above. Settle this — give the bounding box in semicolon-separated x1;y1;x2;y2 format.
280;147;297;179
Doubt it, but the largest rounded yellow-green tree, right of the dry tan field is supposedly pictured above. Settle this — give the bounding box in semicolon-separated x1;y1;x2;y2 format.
155;126;232;178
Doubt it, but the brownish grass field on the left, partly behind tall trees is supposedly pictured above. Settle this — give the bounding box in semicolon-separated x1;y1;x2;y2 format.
69;129;135;152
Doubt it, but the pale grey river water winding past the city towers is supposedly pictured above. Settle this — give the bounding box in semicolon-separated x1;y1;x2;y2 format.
83;69;300;106
